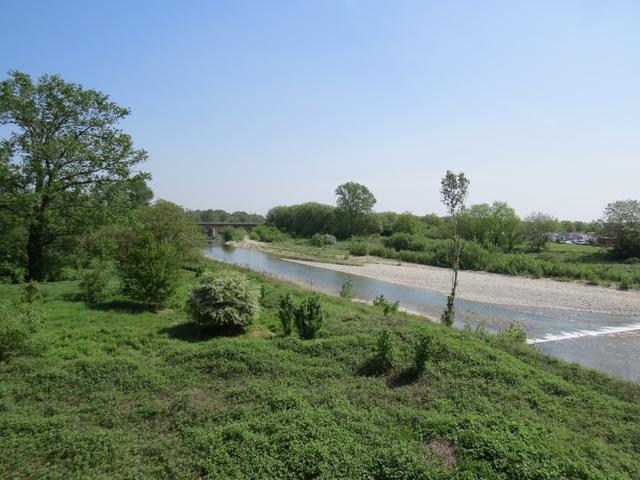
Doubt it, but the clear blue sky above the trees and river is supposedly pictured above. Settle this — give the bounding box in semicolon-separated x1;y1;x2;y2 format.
0;0;640;220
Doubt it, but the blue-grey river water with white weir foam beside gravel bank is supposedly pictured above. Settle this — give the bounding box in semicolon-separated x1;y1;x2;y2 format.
205;243;640;382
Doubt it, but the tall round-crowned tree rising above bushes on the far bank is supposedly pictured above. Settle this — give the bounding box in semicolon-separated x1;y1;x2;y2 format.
336;182;376;237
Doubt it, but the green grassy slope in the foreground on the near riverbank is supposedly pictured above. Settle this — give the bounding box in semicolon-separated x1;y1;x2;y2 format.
0;265;640;480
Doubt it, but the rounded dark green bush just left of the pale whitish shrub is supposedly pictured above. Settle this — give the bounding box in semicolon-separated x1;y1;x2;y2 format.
119;234;180;307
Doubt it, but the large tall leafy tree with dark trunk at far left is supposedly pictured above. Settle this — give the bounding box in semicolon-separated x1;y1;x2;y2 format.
0;71;147;280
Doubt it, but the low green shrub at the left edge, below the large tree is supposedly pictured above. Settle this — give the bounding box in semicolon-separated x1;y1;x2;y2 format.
0;303;44;362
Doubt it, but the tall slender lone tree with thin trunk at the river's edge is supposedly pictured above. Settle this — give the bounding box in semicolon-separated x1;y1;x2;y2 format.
440;170;469;326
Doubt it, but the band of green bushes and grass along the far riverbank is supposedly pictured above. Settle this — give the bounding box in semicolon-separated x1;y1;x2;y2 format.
258;184;640;289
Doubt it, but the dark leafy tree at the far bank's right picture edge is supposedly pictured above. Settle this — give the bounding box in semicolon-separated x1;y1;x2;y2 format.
602;200;640;258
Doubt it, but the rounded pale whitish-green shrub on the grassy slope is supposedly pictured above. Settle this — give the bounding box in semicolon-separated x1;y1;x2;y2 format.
186;272;260;330
